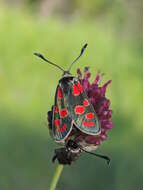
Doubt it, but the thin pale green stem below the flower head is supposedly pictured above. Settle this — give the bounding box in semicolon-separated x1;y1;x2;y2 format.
49;164;63;190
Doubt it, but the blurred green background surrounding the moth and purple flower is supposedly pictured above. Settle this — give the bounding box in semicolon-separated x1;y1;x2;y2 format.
0;0;143;190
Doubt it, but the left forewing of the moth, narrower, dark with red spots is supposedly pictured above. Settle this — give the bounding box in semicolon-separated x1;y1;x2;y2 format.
52;85;72;142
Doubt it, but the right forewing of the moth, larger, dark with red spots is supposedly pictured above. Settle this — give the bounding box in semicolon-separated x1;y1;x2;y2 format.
66;78;101;135
